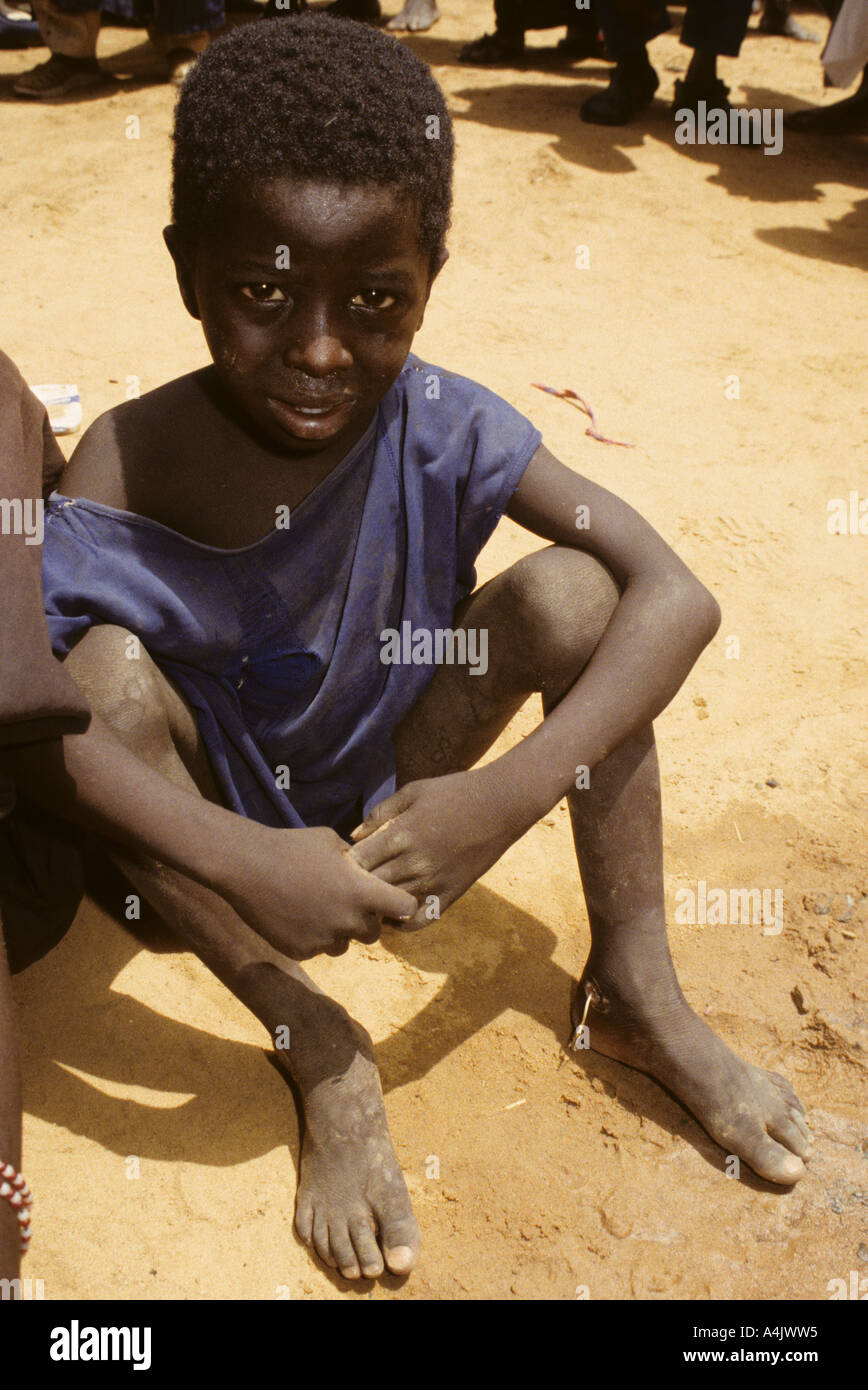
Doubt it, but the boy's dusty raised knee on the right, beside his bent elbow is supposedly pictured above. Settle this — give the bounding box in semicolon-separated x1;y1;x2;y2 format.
511;545;620;689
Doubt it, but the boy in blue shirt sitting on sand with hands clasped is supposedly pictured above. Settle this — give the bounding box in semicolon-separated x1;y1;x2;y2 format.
10;15;808;1279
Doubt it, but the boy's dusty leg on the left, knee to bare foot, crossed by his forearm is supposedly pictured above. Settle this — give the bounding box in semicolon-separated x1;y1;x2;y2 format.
64;627;419;1279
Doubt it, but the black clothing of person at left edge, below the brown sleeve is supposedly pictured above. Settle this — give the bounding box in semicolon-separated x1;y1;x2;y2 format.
0;799;85;974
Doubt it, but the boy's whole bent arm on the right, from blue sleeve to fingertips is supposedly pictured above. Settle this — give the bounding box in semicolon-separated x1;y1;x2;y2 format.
352;448;719;906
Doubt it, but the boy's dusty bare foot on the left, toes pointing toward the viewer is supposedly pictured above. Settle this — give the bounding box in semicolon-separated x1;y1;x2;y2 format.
277;1024;420;1279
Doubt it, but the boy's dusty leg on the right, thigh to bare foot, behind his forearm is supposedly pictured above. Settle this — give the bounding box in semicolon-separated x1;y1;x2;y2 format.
395;546;810;1183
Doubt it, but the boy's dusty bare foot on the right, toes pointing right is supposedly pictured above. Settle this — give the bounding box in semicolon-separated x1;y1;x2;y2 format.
573;966;811;1186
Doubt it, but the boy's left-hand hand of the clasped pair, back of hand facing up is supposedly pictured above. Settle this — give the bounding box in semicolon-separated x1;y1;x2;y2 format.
214;817;416;960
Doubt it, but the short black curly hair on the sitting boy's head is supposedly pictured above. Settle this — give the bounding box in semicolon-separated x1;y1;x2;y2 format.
172;13;453;269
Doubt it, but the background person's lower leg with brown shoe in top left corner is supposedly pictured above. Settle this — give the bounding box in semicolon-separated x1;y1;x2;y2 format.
13;0;109;100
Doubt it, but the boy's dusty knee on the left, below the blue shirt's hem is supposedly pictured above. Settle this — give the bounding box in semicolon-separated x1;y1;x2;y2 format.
64;623;167;744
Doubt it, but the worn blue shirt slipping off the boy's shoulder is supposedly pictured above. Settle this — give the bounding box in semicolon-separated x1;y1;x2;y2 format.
43;354;540;834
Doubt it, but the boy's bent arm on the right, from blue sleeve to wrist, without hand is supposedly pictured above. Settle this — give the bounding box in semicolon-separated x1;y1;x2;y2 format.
491;446;721;826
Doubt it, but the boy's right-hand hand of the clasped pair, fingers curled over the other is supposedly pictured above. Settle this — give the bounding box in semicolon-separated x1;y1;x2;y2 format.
349;769;527;930
